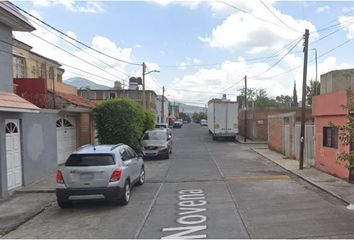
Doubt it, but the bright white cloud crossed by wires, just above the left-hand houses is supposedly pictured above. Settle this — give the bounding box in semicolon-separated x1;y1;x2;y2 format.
14;11;136;86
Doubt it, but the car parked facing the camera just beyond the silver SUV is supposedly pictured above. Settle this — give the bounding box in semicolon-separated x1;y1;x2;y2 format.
140;129;172;159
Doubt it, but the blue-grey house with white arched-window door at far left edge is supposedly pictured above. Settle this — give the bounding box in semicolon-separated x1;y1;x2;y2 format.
0;1;52;199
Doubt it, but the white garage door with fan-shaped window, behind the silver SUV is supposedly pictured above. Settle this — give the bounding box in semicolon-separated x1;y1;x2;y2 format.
57;118;76;164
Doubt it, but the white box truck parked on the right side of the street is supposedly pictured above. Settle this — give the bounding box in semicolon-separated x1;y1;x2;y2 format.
208;96;238;140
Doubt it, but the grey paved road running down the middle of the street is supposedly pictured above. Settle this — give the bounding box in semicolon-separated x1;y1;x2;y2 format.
4;124;354;238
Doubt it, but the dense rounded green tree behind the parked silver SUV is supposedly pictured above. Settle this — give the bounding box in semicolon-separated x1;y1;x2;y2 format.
95;98;155;148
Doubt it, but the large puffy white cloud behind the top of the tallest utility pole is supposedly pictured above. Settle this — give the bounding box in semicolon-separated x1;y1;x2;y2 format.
199;1;317;53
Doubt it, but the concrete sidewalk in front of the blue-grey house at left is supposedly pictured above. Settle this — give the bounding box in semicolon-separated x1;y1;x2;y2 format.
0;173;56;237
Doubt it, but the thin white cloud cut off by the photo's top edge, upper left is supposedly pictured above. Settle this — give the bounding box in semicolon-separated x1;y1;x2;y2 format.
33;0;103;13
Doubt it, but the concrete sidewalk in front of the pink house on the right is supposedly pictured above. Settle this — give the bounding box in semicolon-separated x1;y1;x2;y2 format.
252;146;354;208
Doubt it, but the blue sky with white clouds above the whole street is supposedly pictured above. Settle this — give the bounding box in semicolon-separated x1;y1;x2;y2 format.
12;0;354;106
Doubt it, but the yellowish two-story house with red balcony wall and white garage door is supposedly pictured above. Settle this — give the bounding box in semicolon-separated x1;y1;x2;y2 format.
13;39;96;163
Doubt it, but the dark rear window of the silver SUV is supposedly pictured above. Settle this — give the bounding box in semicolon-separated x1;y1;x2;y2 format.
65;154;115;167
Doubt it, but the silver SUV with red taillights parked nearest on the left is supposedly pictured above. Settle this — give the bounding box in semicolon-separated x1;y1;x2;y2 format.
56;144;145;208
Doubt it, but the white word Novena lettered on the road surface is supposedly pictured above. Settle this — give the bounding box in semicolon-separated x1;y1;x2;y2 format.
162;189;207;239
